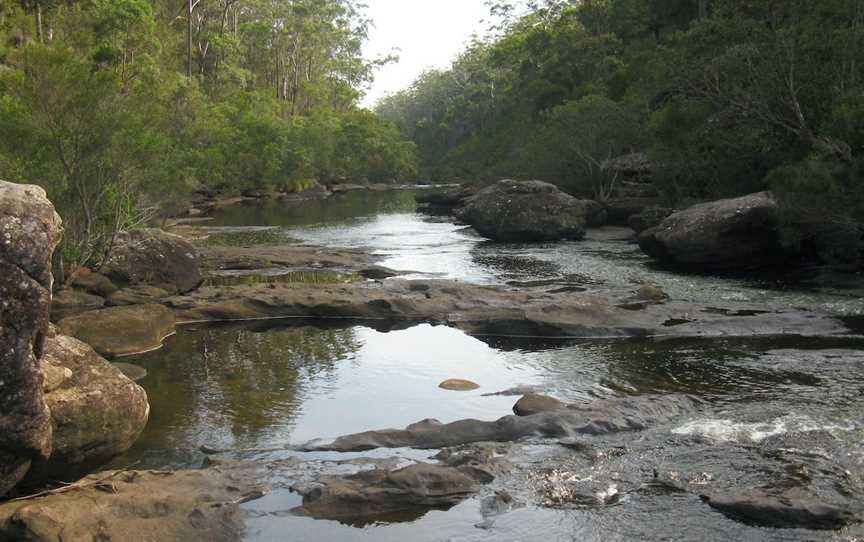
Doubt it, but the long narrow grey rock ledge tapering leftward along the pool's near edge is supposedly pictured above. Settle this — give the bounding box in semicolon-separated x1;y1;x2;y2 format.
301;396;696;452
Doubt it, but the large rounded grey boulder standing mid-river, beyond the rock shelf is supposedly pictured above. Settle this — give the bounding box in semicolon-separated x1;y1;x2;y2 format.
457;180;588;242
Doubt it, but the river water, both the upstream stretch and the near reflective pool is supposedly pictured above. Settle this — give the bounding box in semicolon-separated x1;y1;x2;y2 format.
116;190;864;541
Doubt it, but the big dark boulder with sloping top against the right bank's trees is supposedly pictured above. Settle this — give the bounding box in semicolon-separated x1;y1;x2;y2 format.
639;192;792;271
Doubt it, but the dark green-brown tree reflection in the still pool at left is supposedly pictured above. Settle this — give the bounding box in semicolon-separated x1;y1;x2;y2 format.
124;323;361;468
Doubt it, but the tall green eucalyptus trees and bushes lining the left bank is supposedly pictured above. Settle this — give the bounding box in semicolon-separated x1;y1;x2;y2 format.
0;0;415;272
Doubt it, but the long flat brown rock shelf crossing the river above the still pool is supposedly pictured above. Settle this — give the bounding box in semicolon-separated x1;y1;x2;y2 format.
165;279;847;338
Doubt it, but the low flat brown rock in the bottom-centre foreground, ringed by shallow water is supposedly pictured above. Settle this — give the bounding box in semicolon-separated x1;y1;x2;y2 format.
297;463;478;519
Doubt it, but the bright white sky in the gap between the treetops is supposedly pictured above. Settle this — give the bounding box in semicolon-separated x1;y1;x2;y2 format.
361;0;489;107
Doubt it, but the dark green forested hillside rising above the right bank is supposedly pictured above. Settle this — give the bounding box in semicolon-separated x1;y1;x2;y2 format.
378;0;864;240
